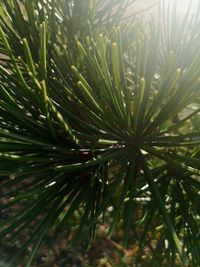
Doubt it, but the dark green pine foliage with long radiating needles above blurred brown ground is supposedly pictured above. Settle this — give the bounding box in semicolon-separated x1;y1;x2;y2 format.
0;0;200;266
